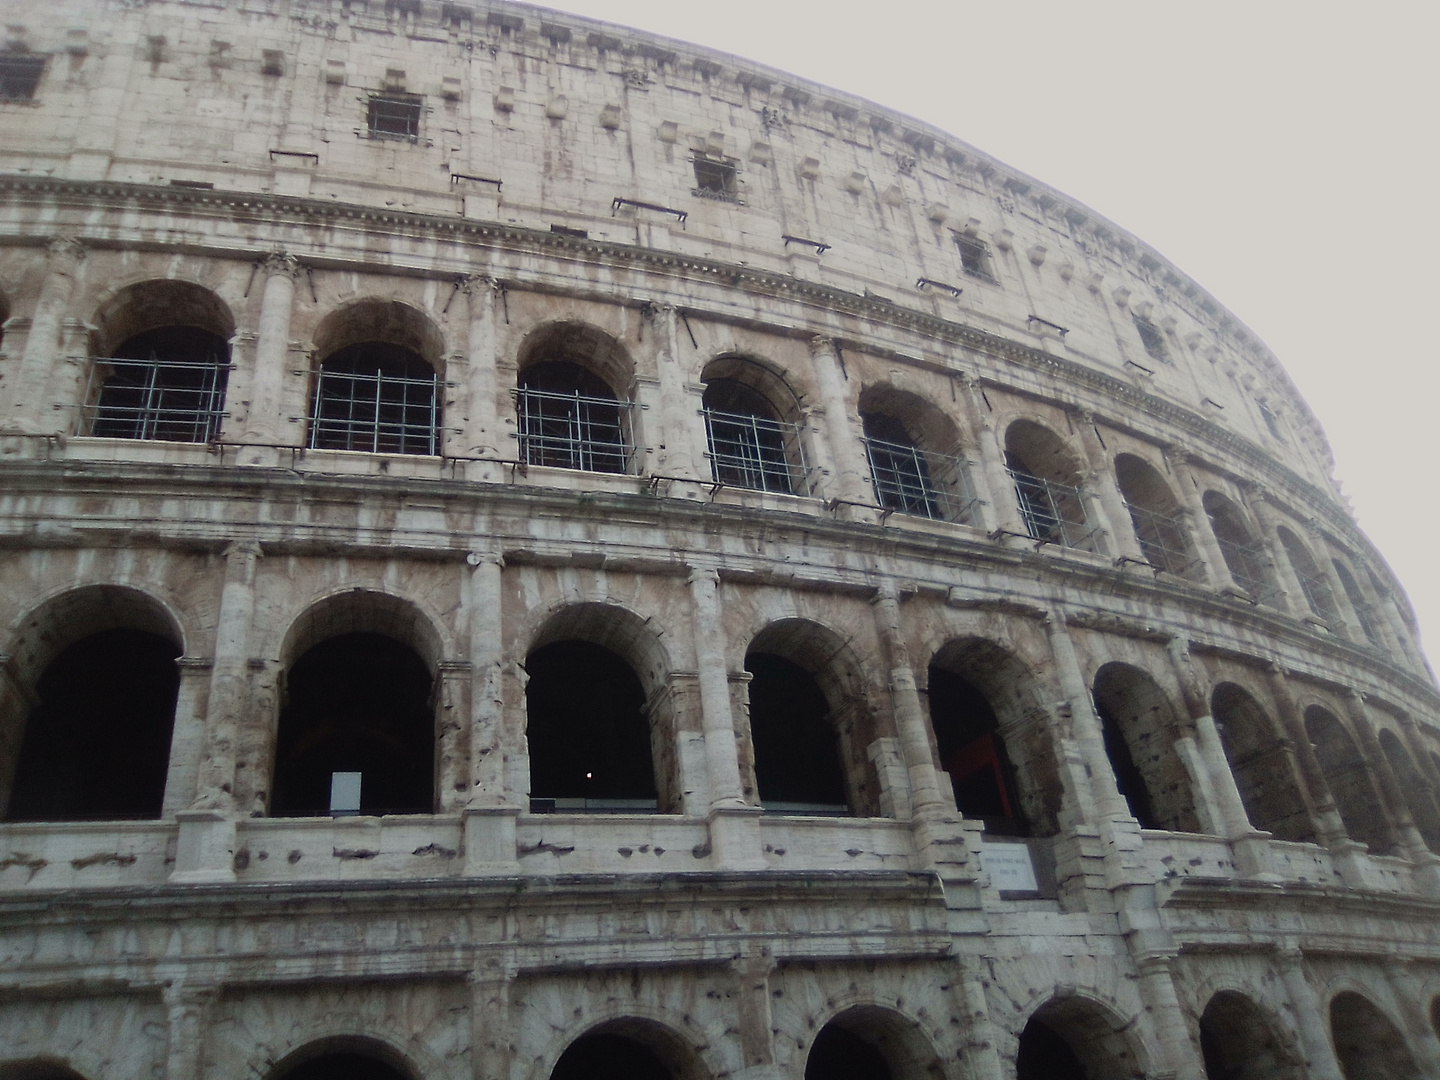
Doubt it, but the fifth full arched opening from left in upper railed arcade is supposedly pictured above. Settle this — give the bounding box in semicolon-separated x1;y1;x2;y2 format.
860;386;976;524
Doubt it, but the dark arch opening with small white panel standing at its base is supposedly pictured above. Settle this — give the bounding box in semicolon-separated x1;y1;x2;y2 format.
271;631;435;816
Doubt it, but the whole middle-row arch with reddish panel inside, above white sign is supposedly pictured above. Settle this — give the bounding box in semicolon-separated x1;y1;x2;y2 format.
926;638;1060;837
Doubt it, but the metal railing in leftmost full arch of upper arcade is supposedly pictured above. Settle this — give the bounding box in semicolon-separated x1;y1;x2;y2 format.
81;356;230;442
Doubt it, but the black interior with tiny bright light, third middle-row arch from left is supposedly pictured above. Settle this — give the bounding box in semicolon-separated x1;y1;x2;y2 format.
526;639;657;812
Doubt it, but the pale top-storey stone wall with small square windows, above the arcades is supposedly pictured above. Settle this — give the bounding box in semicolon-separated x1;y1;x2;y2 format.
0;0;1332;484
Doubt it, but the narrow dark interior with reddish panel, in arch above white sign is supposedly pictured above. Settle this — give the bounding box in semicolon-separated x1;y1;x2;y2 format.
927;661;1030;837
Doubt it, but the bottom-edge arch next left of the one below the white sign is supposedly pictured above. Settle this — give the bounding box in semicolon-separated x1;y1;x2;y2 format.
805;1004;945;1080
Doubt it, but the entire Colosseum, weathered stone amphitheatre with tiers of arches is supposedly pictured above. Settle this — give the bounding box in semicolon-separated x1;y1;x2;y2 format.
0;0;1440;1080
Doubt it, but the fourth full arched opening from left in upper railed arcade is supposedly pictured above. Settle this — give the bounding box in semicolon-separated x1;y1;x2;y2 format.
700;356;809;495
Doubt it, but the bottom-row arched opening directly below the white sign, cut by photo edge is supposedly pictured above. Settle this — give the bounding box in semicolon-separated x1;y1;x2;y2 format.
1015;996;1145;1080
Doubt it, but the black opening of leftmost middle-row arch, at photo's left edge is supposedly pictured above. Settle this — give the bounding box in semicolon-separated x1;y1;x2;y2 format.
6;628;180;821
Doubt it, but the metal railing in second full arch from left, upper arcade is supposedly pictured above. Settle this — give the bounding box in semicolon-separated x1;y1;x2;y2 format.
307;367;441;456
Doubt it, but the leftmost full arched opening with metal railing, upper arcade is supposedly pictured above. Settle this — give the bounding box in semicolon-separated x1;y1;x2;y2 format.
82;281;235;442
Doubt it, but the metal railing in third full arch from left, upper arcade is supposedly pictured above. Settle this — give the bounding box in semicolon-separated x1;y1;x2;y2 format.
516;387;634;472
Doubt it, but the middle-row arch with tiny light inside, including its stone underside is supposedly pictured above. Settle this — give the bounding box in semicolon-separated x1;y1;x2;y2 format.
524;602;681;814
